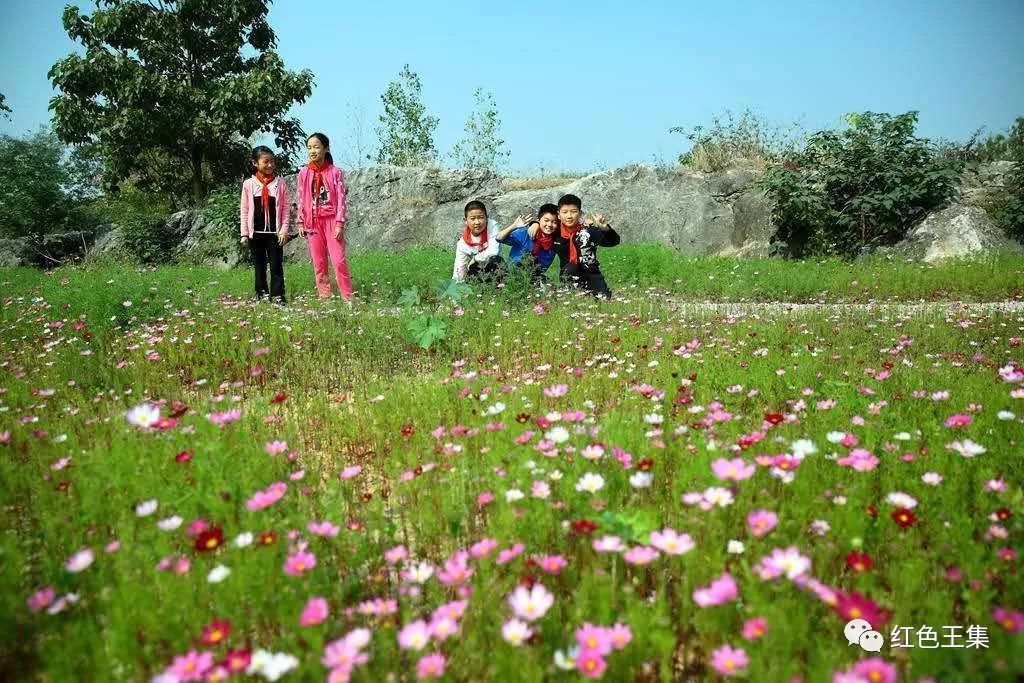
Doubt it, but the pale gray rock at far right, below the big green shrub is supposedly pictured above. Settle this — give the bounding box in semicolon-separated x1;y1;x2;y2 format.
895;204;1020;263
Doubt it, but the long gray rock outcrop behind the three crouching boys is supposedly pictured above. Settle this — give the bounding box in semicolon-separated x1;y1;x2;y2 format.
327;165;774;255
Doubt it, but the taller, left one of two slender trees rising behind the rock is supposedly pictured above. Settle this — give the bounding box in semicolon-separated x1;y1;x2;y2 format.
377;65;437;166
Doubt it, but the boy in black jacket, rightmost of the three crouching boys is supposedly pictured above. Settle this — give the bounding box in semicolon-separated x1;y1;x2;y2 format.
552;195;620;299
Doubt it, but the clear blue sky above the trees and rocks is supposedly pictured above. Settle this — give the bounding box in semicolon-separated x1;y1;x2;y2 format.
0;0;1024;171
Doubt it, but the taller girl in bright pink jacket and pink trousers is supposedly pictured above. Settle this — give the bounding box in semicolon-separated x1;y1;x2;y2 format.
296;133;352;301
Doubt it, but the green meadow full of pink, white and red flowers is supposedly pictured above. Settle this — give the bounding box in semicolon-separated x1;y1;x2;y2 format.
6;252;1024;683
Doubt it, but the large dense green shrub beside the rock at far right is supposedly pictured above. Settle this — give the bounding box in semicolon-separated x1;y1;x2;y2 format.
762;112;964;257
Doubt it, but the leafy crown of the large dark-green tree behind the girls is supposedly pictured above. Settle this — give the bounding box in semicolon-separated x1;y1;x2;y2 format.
49;0;313;203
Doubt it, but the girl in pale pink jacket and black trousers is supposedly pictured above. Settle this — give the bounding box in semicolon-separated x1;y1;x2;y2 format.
240;144;292;303
